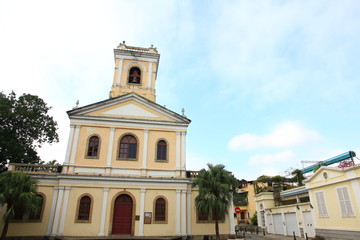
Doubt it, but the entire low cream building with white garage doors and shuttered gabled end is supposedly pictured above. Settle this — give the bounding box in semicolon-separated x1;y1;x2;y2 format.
255;165;360;240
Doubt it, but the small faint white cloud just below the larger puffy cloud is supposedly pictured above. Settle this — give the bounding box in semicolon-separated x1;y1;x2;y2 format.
249;150;295;165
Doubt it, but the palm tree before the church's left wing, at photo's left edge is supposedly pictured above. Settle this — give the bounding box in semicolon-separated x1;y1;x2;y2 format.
0;172;41;240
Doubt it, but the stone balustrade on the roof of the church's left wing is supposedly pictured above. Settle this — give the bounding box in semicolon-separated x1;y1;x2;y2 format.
9;163;62;174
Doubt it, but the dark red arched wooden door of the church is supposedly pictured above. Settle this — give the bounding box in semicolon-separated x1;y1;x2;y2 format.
112;194;133;235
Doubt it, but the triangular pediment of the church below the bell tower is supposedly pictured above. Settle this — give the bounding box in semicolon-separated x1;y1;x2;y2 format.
68;93;190;123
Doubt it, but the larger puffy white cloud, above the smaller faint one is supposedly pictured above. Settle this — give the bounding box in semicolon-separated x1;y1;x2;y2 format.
228;122;321;150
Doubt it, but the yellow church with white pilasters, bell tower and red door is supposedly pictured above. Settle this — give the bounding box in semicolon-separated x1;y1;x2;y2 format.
4;42;235;239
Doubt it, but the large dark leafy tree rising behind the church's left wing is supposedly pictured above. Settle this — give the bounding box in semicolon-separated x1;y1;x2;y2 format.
0;92;59;172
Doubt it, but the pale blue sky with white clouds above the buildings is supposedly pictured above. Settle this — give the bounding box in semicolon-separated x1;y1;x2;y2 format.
0;0;360;180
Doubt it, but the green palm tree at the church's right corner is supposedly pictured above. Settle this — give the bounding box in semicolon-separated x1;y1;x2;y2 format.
193;164;239;240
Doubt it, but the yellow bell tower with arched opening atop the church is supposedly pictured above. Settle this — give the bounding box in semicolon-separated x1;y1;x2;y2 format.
110;41;160;102
